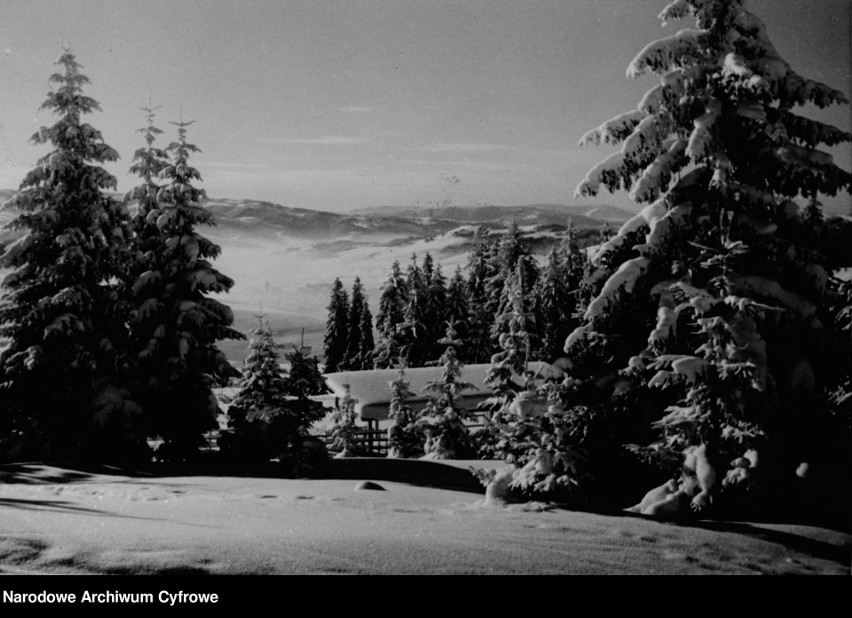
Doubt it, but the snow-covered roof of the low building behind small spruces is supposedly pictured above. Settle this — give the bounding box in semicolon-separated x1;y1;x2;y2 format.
323;362;561;420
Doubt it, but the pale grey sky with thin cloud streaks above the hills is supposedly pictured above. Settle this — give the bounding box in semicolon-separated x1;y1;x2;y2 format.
0;0;852;213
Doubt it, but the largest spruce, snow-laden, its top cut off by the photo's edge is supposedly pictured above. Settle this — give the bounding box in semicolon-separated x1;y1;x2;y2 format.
565;0;852;512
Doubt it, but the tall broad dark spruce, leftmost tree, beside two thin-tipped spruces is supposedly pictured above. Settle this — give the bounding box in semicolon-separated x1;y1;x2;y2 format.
0;49;147;461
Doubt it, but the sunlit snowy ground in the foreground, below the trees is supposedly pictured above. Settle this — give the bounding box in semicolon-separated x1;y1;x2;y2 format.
0;459;852;575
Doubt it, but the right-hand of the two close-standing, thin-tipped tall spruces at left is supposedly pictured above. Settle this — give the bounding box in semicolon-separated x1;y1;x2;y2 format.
130;119;245;460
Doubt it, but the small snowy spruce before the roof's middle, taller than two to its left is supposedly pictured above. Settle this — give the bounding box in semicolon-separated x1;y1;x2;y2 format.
417;323;476;459
